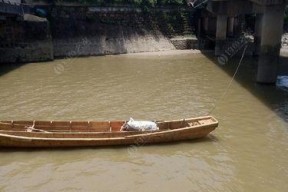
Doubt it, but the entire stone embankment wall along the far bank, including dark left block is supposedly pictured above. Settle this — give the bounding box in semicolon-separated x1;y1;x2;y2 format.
0;5;197;63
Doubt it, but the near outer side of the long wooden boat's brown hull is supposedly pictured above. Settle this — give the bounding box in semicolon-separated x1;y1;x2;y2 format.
0;115;218;148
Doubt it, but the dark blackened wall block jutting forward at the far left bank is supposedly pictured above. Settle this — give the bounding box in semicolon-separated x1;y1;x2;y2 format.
0;15;54;63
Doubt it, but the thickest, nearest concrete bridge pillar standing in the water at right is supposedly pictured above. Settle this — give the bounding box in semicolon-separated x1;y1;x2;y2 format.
256;4;285;83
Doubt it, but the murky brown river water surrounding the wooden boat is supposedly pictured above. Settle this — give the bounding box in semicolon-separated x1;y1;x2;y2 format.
0;51;288;192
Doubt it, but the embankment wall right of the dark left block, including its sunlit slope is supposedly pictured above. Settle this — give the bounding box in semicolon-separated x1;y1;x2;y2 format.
51;6;192;57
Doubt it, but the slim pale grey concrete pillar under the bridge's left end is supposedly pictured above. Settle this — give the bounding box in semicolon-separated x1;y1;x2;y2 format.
215;15;227;56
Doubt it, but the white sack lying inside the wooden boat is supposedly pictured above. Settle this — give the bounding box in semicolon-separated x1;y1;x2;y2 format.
122;118;159;131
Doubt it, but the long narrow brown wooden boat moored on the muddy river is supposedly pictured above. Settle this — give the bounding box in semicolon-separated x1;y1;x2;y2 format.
0;116;218;148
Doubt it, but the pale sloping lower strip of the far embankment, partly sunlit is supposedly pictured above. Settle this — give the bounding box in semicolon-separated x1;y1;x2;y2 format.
53;31;175;57
